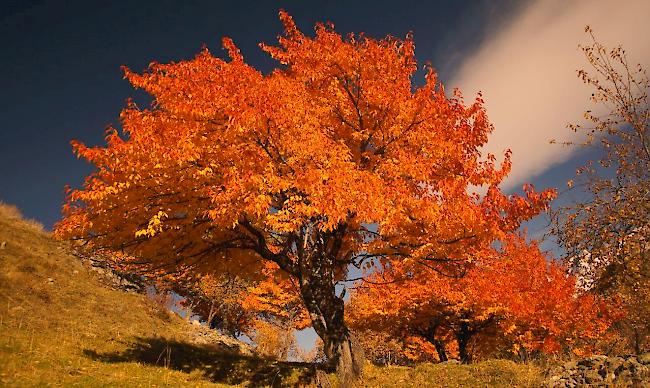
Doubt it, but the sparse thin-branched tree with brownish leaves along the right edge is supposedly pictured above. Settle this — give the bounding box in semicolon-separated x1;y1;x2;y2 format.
554;27;650;353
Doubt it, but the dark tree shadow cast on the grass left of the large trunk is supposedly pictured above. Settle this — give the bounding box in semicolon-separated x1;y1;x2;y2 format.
83;337;314;387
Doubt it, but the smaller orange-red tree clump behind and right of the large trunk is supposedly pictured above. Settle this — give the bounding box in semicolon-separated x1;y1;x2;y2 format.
348;235;617;362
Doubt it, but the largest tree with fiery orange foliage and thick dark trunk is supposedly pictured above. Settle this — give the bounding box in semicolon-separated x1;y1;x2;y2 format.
56;12;553;382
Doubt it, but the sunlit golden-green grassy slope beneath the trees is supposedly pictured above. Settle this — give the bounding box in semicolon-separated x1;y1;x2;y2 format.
0;204;540;387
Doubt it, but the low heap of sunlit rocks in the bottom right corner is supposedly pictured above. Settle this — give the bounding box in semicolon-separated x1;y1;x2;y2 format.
544;353;650;388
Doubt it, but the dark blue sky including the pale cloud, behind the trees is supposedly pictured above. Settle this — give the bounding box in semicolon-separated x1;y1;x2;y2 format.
0;0;650;352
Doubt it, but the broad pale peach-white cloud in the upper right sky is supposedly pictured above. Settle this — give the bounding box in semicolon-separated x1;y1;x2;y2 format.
447;0;650;189
